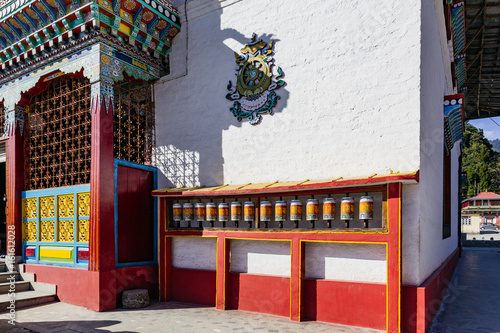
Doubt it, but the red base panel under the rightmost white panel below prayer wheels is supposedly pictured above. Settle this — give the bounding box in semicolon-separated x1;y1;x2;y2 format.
303;279;386;330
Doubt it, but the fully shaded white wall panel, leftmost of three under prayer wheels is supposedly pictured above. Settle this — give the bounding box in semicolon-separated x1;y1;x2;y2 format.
172;237;217;271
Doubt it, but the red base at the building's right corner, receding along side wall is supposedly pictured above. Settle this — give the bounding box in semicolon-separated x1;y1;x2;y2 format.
401;248;459;333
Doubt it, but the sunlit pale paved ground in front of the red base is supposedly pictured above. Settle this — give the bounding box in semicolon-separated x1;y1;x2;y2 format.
0;302;381;333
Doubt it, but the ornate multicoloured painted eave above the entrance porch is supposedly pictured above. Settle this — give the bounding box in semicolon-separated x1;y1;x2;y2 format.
0;0;180;77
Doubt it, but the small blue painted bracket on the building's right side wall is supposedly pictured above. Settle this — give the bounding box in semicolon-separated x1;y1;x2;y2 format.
443;94;465;153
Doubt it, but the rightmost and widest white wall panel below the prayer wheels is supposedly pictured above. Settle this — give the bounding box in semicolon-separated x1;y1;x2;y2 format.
305;243;387;283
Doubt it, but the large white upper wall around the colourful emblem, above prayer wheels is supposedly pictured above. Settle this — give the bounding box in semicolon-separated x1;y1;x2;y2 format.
155;0;420;187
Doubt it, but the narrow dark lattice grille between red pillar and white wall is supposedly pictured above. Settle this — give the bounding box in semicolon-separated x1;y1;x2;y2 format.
113;81;155;165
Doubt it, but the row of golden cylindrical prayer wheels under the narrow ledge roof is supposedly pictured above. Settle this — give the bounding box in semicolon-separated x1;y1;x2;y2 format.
172;196;373;228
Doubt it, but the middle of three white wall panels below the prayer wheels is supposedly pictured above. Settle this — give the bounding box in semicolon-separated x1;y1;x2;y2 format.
230;239;292;277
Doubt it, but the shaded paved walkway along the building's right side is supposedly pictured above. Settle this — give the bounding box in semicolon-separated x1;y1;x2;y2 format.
430;247;500;333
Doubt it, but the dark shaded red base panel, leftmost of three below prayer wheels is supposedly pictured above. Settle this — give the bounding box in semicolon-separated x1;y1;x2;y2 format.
170;268;216;306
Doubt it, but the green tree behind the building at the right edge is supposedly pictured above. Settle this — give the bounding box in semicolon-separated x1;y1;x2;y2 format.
462;124;500;198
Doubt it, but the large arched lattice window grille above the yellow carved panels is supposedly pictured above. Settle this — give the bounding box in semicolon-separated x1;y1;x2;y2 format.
24;75;91;190
